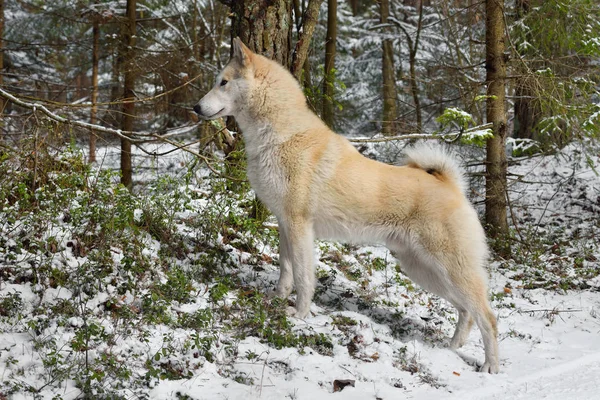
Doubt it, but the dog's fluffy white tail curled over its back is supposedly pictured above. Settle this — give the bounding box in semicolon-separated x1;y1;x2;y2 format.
404;143;467;194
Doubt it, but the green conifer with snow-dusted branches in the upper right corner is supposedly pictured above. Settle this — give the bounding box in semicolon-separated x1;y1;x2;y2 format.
510;0;600;144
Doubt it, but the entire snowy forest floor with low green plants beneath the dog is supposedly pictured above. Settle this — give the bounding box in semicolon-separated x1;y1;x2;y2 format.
0;136;600;400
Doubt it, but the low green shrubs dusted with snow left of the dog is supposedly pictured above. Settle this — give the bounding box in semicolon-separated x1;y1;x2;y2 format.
0;143;322;399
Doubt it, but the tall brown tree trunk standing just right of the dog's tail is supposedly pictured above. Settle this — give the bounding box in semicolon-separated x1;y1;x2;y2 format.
485;0;510;256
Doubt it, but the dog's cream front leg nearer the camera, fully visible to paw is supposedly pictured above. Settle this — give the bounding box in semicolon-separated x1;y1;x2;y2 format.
285;219;315;318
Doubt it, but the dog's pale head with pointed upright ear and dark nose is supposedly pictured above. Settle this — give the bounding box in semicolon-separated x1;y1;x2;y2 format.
194;38;256;119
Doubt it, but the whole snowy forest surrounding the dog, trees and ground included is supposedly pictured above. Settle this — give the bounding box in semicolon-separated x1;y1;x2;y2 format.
0;0;600;400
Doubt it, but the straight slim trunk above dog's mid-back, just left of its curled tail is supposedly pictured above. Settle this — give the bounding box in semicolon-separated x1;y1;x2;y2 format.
380;0;398;136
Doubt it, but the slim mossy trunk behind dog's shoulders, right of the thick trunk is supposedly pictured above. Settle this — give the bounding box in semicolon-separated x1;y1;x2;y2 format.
322;0;337;128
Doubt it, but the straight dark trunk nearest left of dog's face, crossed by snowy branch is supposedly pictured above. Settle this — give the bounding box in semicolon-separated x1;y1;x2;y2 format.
121;0;136;190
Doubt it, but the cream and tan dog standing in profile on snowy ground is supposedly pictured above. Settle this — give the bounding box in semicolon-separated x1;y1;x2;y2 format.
194;38;499;373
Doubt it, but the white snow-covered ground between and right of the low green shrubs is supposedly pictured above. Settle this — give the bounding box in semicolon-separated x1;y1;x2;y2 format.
0;138;600;400
